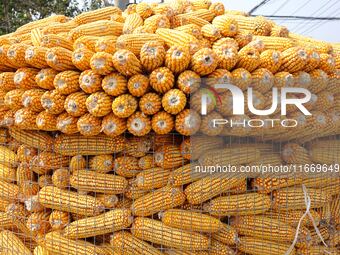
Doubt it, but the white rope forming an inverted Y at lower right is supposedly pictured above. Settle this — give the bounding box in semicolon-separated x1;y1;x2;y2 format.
285;184;330;255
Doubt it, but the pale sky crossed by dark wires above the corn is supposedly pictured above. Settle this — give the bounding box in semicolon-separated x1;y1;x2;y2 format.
78;0;340;42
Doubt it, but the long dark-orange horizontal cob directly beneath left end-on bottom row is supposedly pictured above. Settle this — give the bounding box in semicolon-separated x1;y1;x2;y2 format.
54;132;125;156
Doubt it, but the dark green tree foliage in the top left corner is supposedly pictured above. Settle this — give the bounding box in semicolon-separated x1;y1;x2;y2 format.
0;0;82;34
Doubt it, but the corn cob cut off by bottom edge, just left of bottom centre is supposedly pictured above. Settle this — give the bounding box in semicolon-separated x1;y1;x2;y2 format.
110;231;163;255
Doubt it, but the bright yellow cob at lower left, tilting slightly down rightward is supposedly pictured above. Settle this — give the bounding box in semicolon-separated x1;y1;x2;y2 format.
38;186;104;216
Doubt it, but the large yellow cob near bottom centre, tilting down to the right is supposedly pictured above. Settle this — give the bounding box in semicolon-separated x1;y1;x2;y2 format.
131;218;210;250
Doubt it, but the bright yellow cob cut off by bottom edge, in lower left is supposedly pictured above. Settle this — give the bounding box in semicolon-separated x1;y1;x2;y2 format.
42;231;107;255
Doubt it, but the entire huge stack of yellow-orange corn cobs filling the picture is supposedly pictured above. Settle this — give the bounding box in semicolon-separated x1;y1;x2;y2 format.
0;0;340;255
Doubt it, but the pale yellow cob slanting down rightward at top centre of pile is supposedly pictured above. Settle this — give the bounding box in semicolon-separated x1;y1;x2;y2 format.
156;28;200;53
